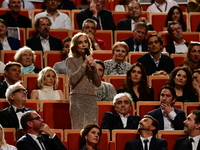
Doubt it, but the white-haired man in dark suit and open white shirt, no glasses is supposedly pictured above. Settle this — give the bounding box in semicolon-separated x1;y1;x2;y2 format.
101;93;140;131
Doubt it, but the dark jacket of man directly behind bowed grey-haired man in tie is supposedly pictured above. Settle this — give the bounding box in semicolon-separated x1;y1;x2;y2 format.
117;18;154;31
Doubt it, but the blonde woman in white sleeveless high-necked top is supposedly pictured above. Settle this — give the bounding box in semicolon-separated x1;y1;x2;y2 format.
31;67;65;100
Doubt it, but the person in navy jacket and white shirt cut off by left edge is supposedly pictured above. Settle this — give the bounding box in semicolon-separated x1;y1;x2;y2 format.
0;19;21;50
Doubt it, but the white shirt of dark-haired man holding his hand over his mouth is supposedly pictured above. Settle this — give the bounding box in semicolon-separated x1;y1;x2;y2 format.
161;107;176;130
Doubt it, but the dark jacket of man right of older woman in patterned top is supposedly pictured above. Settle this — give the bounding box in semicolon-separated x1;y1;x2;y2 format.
137;53;175;75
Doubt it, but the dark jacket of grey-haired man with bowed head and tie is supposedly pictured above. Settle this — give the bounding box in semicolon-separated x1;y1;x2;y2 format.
121;37;148;52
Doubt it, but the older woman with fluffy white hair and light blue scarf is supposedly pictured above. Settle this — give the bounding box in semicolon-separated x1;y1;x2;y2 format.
14;46;42;74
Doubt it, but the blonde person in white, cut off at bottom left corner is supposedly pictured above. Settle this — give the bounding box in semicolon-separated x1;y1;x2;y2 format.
0;124;17;150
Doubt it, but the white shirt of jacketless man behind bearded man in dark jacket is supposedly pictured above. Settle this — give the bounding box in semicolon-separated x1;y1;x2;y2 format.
34;11;72;30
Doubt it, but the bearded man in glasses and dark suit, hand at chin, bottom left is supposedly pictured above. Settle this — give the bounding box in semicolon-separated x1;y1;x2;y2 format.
17;111;67;150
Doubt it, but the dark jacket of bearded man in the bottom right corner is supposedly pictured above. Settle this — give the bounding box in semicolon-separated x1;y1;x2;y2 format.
173;136;200;150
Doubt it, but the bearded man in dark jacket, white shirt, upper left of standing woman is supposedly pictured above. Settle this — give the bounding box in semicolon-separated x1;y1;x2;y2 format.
26;17;62;52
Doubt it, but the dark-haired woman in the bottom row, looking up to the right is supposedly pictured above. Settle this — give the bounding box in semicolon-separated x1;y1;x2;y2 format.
79;123;102;150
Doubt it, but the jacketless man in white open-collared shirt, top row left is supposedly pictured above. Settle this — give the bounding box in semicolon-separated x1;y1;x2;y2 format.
34;0;72;30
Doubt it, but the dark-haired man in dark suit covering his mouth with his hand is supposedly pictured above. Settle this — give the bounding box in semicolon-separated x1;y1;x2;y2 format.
147;85;185;130
